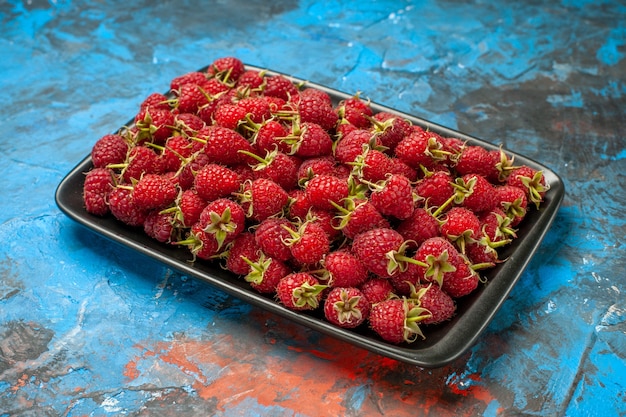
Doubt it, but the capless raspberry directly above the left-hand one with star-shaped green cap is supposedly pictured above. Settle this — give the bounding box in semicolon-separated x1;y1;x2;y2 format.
194;163;241;201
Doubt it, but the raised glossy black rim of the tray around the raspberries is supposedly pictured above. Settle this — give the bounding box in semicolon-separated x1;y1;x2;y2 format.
55;65;565;368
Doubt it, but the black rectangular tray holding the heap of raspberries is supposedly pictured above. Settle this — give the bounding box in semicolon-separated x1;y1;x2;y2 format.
55;66;565;367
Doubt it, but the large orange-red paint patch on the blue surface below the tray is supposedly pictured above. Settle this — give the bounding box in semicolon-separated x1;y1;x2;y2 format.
124;310;493;417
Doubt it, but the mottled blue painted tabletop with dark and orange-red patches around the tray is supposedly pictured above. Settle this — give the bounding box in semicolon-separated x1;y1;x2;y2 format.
0;0;626;417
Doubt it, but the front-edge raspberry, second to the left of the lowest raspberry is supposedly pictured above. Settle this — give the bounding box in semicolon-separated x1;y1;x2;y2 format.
276;272;326;311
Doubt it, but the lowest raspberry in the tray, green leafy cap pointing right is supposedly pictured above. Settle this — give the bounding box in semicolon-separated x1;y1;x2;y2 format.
369;298;430;344
